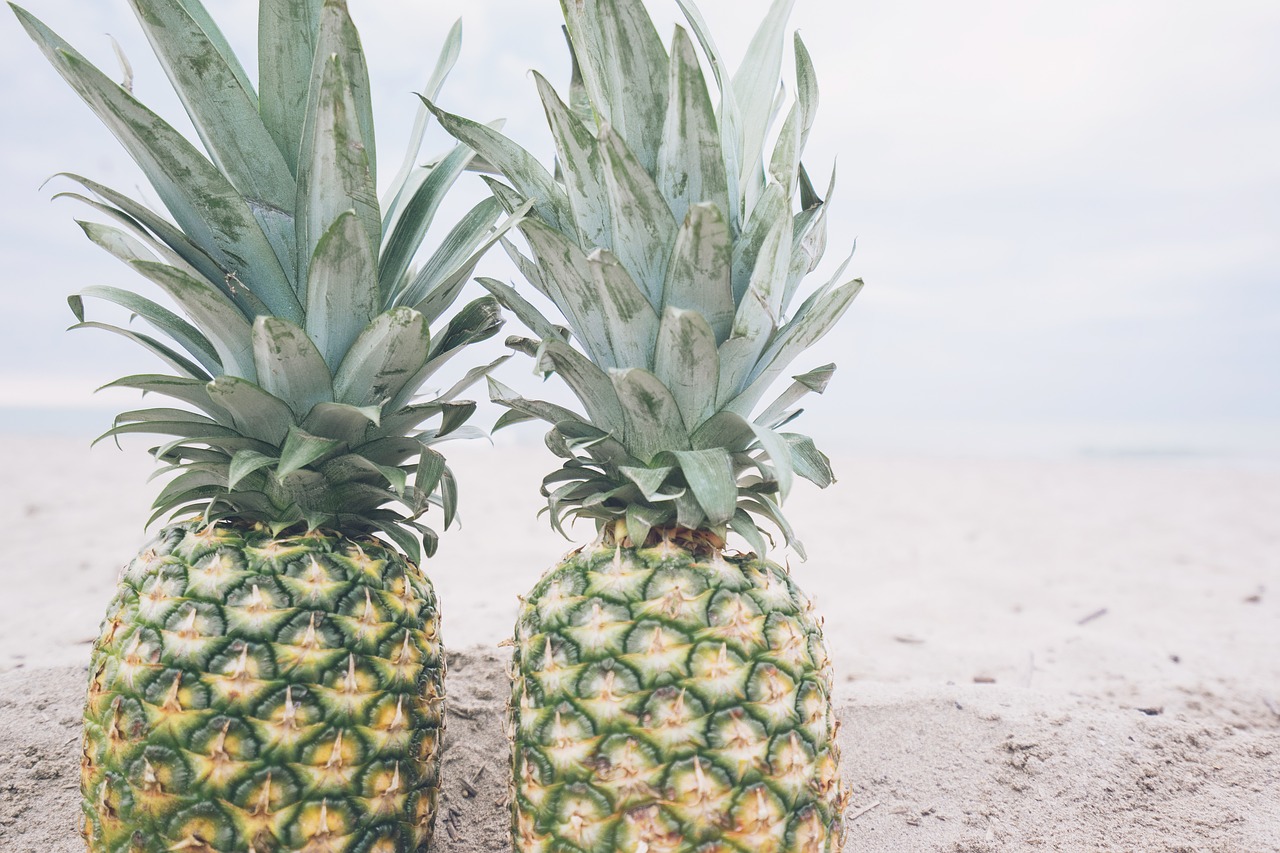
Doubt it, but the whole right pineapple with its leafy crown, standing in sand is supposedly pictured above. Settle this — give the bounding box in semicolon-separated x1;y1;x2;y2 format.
435;0;861;853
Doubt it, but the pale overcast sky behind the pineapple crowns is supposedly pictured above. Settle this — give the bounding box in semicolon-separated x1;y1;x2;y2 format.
0;0;1280;455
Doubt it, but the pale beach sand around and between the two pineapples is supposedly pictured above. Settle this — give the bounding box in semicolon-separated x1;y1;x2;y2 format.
0;439;1280;853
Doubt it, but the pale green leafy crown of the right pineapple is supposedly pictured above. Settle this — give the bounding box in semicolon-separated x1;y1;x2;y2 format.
433;0;861;556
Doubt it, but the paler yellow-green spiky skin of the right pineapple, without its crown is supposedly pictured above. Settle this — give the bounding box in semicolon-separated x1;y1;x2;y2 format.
508;539;847;853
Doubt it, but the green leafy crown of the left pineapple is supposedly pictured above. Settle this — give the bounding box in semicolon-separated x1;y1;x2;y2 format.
13;0;527;560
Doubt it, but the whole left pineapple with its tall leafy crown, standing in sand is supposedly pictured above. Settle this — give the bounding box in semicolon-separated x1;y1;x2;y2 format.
14;0;513;853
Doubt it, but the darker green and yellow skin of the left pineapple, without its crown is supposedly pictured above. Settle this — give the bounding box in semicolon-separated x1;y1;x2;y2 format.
81;524;444;853
